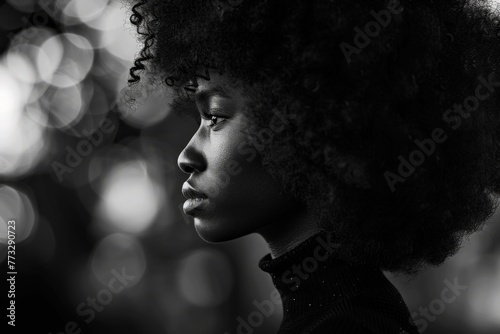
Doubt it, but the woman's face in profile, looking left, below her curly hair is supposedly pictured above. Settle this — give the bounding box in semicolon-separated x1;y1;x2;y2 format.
178;74;304;242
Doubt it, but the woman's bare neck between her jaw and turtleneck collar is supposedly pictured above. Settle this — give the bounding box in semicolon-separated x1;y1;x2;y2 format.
258;210;320;259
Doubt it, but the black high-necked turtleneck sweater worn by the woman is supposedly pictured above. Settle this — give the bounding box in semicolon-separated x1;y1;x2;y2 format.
259;233;418;334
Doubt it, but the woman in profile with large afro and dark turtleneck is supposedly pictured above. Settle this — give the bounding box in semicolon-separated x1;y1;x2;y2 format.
122;0;500;333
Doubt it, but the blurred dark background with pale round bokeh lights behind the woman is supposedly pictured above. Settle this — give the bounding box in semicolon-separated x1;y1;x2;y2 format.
0;0;500;334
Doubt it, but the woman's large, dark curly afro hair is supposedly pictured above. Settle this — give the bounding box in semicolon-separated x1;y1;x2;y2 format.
123;0;500;274
